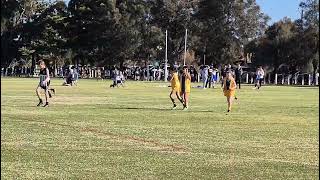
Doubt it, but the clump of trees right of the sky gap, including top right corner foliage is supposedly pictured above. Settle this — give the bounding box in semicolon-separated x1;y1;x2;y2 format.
246;0;319;72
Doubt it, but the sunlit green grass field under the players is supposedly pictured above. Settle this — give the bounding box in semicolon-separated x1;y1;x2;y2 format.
1;78;319;180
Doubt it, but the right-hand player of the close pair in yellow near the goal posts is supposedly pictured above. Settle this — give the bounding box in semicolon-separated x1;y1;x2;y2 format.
180;66;191;110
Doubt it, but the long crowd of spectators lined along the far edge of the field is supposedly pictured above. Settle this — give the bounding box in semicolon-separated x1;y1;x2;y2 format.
8;64;319;88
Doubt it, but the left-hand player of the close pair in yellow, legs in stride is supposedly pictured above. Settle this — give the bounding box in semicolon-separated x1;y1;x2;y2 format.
170;68;183;109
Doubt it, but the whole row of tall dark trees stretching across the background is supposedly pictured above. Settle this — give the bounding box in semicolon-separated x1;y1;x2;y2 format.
1;0;319;74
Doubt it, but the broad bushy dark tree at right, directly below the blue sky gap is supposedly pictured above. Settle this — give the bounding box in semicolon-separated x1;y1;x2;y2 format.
246;18;319;72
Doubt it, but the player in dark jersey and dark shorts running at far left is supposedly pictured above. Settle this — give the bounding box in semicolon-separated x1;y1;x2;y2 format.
36;60;55;107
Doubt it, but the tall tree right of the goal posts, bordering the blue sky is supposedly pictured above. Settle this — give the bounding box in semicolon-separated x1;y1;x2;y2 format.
197;0;268;64
